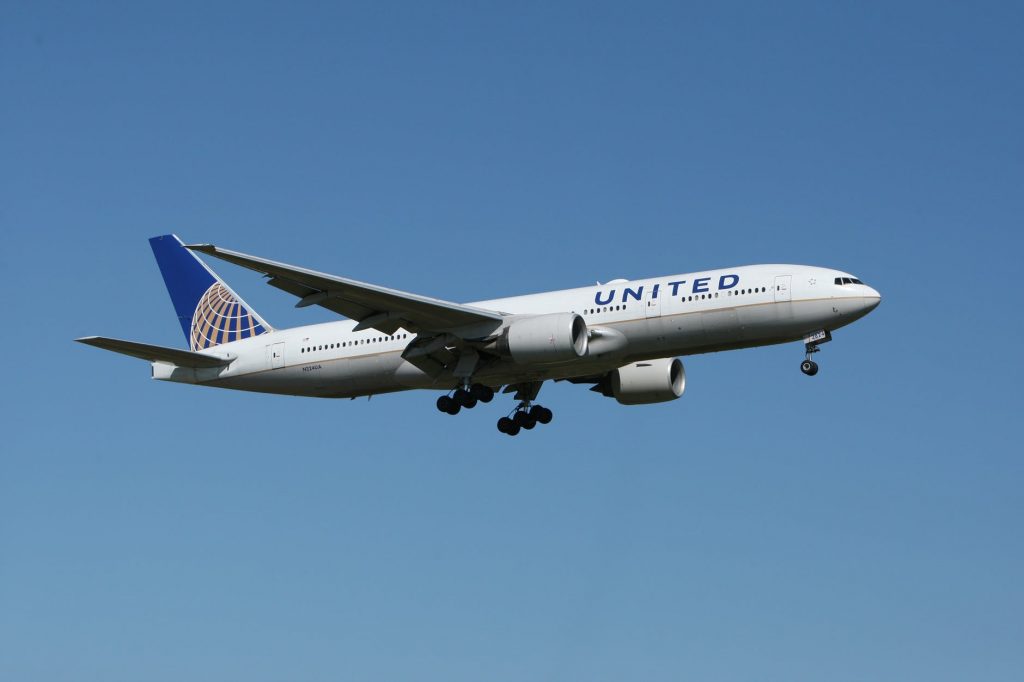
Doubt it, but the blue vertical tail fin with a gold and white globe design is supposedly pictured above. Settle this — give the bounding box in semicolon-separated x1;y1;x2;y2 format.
150;235;272;350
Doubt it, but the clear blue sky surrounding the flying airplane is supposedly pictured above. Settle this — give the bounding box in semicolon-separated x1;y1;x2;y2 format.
0;0;1024;682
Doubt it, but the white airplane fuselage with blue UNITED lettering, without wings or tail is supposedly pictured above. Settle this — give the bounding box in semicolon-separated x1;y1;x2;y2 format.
154;265;881;397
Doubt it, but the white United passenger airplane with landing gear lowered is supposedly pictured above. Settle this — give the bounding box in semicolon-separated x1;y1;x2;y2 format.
76;235;882;435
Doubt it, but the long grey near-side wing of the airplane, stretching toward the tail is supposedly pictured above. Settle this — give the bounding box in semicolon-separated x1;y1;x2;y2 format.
185;244;502;334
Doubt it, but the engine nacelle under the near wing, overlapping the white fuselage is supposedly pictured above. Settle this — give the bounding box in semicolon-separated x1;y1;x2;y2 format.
500;312;587;365
